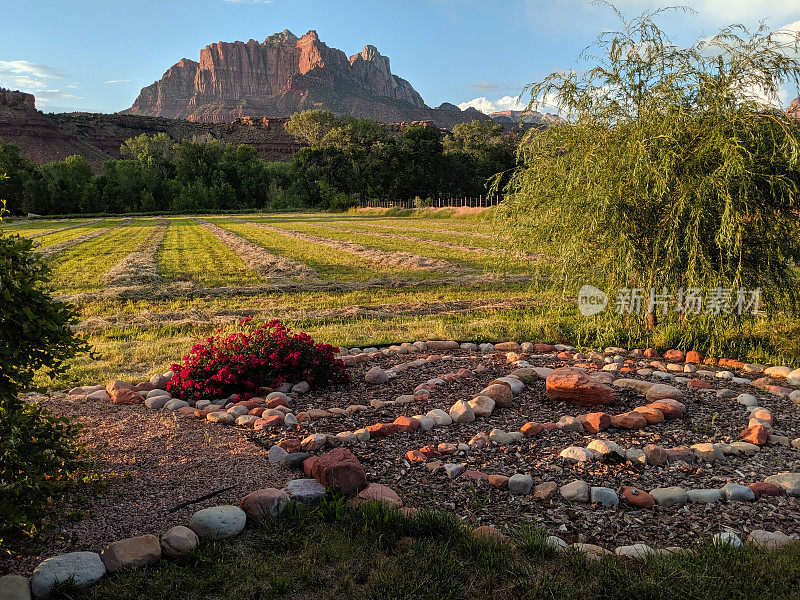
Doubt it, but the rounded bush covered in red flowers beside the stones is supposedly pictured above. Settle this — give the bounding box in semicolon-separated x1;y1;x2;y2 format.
167;317;350;400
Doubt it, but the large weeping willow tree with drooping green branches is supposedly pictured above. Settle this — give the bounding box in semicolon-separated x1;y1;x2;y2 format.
497;7;800;350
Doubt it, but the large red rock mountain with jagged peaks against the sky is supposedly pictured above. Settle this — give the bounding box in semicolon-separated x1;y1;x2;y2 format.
123;30;488;128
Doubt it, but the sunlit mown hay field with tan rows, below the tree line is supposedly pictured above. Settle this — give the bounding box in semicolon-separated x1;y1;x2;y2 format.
4;211;788;387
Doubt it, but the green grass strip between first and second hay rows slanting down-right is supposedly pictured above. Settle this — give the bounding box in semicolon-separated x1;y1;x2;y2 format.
215;219;440;281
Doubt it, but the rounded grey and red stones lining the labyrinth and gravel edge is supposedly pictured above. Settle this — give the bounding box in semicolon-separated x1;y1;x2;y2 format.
15;341;800;600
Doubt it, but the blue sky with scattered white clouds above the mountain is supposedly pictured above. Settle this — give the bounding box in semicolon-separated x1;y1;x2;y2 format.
0;0;800;112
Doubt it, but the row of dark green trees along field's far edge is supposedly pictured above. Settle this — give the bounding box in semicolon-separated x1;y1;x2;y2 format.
0;110;519;215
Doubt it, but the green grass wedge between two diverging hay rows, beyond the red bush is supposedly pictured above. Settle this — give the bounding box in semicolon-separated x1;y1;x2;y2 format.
156;218;261;287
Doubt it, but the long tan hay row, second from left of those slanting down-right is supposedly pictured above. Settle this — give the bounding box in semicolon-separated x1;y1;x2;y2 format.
238;217;469;273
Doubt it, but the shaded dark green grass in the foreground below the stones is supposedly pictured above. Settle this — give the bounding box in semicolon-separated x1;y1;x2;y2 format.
48;501;800;600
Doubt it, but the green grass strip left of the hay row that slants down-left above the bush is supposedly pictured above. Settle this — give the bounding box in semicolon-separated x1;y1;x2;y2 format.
53;220;154;293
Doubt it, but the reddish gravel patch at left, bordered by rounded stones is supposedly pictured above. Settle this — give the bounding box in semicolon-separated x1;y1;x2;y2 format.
0;394;292;575
